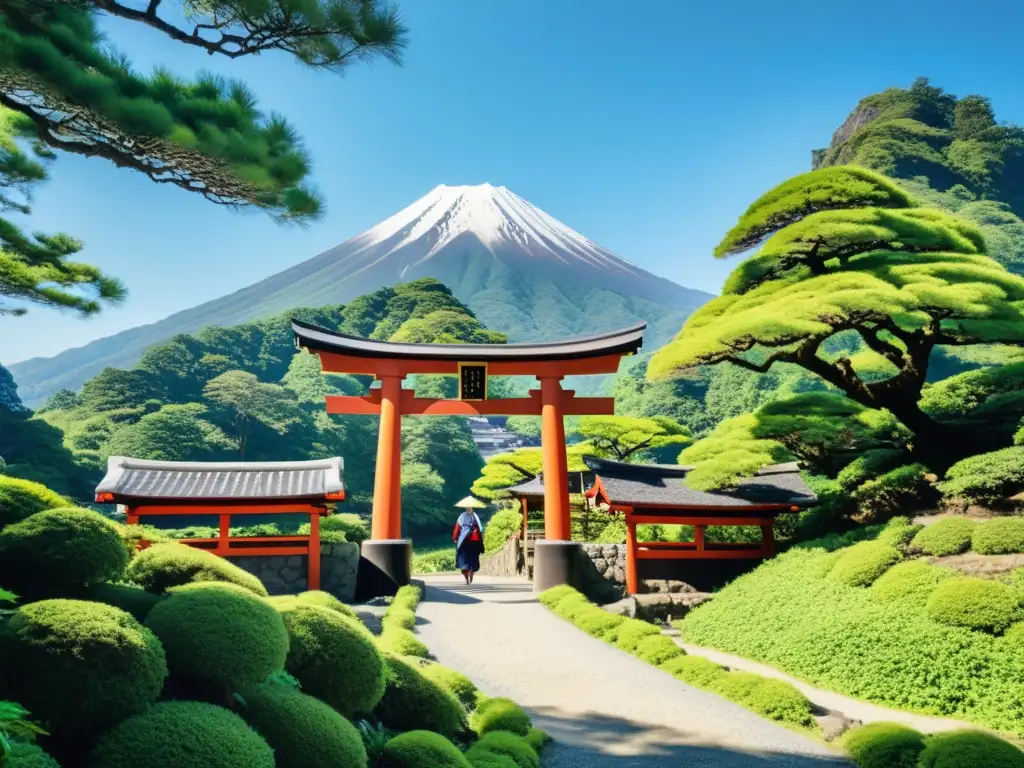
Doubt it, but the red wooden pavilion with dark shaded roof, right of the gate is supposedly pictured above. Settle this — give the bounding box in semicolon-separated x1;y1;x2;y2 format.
584;456;817;595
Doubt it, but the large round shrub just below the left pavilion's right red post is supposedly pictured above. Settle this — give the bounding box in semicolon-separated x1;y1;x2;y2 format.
281;601;385;718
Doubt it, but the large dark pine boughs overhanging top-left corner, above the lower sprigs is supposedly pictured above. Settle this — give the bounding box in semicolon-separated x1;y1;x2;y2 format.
0;0;406;221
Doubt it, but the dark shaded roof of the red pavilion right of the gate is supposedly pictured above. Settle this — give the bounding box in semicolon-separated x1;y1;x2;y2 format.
584;456;817;511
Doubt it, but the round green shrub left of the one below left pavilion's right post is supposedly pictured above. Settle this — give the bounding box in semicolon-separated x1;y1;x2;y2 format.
145;582;288;690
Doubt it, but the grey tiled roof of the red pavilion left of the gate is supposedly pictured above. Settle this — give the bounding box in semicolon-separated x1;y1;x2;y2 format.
96;456;345;501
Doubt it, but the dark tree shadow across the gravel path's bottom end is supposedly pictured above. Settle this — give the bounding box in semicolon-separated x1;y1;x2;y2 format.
529;708;850;768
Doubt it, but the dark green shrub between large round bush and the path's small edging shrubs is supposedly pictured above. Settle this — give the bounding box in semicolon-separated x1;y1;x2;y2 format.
374;654;466;738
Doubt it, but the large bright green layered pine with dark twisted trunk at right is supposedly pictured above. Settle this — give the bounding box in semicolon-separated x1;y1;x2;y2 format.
648;167;1024;471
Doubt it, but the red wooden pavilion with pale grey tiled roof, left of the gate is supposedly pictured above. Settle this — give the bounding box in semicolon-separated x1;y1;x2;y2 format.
96;456;345;590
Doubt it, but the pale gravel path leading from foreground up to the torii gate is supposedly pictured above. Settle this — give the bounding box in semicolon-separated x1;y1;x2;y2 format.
417;574;849;768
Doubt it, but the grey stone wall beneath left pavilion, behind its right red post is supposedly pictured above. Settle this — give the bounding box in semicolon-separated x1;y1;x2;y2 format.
231;542;359;602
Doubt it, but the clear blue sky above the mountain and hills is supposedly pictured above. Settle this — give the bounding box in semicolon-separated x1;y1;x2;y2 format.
0;0;1024;364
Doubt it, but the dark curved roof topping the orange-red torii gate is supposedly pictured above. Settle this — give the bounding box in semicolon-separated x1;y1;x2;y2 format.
292;319;647;362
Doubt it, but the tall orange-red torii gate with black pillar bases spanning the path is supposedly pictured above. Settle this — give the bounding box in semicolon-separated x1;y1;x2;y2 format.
292;319;647;591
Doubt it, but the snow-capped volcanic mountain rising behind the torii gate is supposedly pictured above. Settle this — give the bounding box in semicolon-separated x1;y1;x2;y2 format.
10;184;710;406
